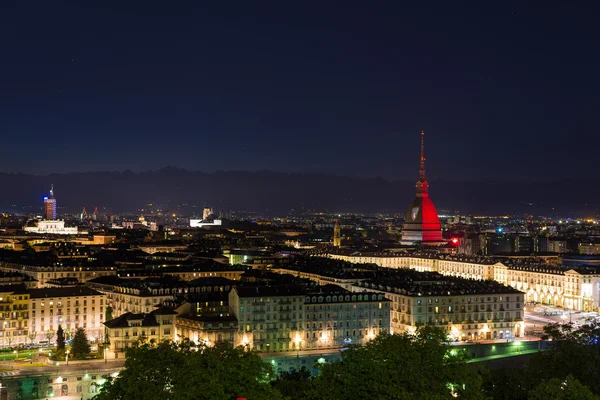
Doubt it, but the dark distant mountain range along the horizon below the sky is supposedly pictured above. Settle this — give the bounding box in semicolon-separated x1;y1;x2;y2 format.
0;167;600;217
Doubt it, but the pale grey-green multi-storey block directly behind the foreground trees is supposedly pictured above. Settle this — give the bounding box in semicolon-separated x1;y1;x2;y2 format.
229;286;390;352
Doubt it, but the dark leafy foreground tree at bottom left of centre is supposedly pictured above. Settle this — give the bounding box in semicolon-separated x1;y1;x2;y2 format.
95;341;282;400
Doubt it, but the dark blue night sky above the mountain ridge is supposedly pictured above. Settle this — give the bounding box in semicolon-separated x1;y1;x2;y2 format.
0;1;600;180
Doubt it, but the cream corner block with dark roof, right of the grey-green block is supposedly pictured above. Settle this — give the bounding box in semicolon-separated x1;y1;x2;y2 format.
356;271;525;340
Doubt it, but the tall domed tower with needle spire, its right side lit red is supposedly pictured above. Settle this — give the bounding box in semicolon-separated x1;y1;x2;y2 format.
401;131;445;245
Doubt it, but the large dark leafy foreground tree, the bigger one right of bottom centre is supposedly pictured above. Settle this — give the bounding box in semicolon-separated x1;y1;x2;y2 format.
307;327;485;400
